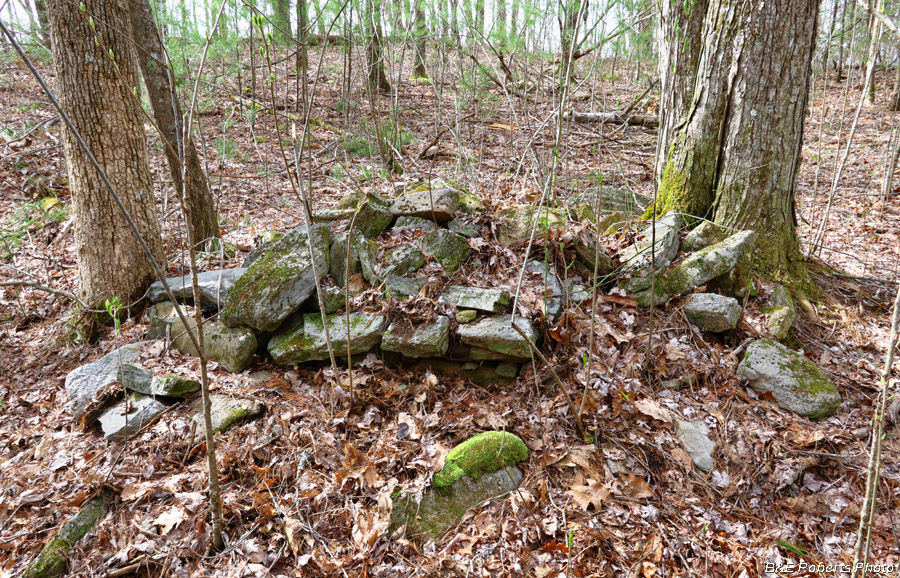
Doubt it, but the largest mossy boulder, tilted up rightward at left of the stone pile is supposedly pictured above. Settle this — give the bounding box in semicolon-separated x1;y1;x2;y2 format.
221;224;331;332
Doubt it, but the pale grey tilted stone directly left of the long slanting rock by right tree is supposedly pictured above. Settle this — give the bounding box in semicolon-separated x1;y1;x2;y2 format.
618;213;684;293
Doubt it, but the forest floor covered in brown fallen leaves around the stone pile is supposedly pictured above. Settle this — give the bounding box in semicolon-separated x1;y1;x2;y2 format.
0;50;900;578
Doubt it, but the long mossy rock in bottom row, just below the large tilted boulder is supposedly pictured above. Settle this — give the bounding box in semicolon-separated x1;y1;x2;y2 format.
269;311;386;365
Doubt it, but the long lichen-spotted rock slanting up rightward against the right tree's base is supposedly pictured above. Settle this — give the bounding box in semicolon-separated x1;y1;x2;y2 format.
634;231;756;307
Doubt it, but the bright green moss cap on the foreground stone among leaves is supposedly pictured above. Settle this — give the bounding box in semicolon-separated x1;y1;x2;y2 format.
432;431;528;488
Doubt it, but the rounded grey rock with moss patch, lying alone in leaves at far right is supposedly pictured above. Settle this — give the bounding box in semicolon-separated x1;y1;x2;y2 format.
737;339;841;419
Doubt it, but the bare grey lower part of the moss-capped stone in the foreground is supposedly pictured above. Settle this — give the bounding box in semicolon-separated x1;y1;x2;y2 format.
389;466;523;540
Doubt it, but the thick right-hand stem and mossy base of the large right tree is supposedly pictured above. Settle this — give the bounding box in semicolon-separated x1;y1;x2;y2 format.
656;0;819;280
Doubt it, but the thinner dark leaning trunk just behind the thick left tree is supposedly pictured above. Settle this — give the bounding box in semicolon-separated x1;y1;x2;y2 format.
131;0;219;248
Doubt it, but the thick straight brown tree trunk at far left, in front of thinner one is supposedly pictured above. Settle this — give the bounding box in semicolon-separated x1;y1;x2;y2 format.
47;0;163;310
